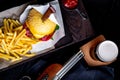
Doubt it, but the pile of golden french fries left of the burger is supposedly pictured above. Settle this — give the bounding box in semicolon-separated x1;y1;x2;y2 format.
0;18;38;62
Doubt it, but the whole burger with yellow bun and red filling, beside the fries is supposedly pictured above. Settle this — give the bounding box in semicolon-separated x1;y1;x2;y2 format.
23;8;59;41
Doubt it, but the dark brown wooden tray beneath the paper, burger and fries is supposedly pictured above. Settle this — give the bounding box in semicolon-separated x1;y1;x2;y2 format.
0;0;96;79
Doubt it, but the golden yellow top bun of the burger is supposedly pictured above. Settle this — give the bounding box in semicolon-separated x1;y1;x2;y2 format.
25;8;56;39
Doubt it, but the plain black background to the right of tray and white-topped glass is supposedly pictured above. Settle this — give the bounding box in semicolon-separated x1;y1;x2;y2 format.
83;0;120;80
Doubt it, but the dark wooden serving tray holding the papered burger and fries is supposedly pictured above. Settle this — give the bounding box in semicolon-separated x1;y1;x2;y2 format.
0;0;95;72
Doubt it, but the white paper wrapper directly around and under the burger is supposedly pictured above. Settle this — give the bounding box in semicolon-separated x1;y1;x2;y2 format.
20;2;65;53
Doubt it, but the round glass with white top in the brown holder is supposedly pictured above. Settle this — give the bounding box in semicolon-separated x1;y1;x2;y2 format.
95;40;118;62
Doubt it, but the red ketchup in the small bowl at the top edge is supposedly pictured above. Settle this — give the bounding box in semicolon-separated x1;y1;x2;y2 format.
62;0;78;9
